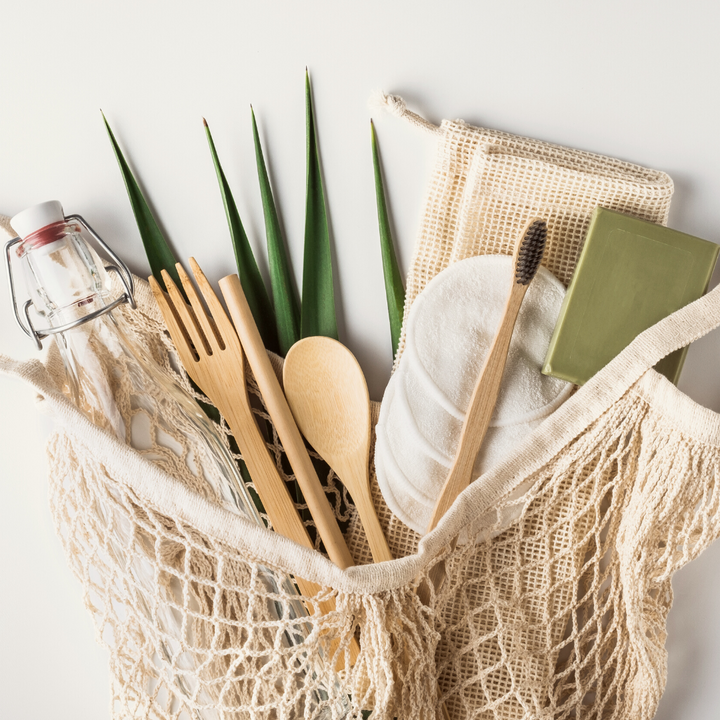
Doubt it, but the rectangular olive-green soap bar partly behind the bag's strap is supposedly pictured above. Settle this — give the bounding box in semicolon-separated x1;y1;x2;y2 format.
542;208;720;385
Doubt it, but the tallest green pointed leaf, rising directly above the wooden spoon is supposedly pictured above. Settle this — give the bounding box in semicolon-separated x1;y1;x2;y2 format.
300;71;338;340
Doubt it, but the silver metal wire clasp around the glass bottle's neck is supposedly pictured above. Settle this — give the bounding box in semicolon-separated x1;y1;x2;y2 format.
5;215;135;350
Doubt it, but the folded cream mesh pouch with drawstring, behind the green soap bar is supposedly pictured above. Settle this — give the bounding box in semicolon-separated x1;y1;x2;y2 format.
383;96;673;364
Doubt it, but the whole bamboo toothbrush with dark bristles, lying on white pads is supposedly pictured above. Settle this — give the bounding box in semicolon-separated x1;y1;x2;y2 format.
428;218;547;532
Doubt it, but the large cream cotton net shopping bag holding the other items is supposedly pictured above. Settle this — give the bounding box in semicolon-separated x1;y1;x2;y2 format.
0;105;720;720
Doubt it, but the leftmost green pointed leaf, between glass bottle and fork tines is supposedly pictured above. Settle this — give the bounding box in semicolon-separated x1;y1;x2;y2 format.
102;113;184;294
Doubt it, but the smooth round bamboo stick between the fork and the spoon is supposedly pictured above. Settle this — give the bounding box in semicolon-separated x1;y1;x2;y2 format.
219;275;355;569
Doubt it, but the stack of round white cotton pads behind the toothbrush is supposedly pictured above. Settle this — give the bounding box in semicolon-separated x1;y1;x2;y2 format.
375;255;572;534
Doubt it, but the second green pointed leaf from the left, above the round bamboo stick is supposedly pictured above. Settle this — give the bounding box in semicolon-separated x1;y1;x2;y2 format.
203;118;279;353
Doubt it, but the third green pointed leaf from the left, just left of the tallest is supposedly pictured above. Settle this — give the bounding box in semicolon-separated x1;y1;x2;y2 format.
251;108;300;357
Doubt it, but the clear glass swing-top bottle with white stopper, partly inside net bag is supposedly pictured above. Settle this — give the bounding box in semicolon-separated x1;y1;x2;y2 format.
6;201;349;720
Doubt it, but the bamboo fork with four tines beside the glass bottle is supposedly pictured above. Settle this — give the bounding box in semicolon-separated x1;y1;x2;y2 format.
149;261;359;662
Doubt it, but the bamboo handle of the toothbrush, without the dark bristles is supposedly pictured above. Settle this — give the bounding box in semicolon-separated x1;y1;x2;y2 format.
428;283;528;532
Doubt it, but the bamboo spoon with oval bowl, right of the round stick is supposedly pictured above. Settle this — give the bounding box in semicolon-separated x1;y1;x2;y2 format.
283;337;393;562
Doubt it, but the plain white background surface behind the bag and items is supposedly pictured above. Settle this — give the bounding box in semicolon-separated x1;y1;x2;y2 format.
0;0;720;720
